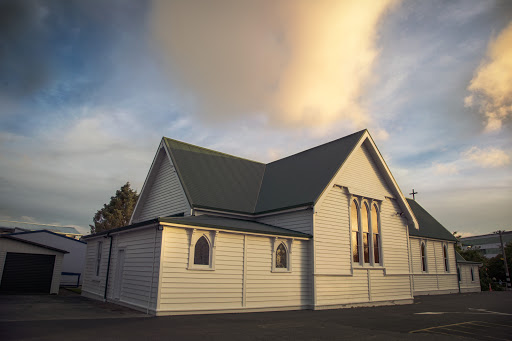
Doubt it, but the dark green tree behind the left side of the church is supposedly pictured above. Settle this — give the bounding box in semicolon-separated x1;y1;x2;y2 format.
89;182;139;233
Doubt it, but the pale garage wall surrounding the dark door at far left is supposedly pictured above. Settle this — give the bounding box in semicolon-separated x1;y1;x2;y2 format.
0;238;63;294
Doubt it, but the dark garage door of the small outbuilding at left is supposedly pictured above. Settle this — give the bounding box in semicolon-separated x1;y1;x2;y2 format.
0;252;55;293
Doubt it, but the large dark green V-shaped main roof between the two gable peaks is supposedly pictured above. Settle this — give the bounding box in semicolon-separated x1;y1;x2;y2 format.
164;130;365;214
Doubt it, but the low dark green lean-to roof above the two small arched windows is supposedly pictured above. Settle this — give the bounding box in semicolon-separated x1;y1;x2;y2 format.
159;215;312;238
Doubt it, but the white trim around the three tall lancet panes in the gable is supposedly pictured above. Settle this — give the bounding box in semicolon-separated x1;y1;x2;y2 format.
348;195;384;269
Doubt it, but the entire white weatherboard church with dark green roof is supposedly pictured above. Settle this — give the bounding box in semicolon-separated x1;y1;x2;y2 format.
82;130;479;315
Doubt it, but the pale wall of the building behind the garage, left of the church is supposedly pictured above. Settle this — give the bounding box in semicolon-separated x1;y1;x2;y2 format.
8;231;87;285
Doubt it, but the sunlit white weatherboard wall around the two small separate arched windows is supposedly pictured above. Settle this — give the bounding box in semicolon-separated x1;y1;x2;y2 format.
157;226;311;315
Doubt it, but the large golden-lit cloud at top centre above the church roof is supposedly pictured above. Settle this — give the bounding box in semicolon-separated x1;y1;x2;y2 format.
151;0;394;129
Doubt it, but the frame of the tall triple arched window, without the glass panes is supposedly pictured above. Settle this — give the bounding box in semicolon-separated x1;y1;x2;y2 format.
349;195;384;269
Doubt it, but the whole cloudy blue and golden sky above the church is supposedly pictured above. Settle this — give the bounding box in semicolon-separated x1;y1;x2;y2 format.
0;0;512;234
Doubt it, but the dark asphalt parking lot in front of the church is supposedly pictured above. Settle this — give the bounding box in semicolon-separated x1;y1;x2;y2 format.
0;292;512;340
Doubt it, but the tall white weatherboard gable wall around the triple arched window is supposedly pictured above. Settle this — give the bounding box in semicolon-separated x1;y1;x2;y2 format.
314;144;412;309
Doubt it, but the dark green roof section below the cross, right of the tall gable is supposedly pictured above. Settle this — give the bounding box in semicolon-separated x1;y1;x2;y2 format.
407;198;457;242
